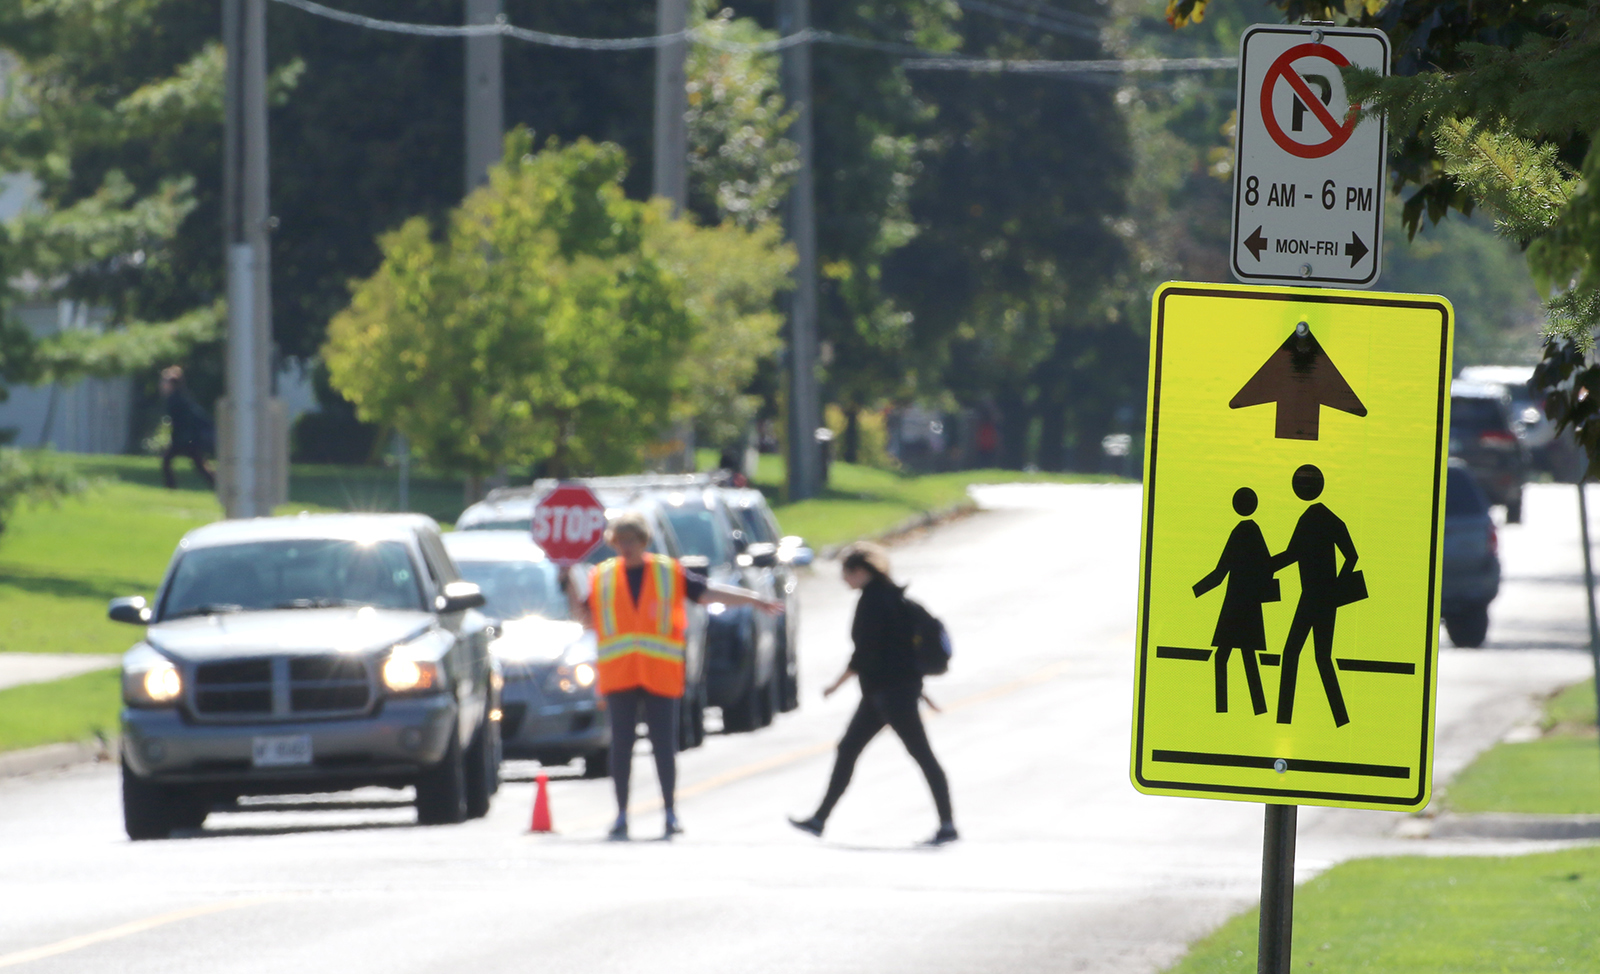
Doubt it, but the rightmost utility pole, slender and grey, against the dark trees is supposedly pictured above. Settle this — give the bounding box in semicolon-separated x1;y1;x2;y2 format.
778;0;822;501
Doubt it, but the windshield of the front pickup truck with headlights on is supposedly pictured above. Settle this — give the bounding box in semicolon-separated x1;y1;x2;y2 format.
162;537;422;619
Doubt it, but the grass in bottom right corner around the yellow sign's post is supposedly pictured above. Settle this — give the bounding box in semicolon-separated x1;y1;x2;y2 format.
1170;848;1600;974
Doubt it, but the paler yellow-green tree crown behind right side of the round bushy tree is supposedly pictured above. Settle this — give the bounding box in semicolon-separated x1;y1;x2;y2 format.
646;219;794;443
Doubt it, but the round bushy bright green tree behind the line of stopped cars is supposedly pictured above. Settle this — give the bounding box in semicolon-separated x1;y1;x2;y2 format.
323;130;691;477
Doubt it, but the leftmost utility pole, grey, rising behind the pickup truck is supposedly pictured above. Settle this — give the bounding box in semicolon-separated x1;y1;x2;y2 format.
218;0;288;518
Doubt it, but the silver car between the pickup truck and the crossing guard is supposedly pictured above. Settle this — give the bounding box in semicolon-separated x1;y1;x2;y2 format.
443;531;611;777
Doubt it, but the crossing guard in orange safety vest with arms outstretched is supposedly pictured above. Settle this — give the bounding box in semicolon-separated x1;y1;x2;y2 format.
562;510;782;841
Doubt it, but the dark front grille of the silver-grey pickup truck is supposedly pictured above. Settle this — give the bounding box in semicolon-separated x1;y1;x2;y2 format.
192;654;373;721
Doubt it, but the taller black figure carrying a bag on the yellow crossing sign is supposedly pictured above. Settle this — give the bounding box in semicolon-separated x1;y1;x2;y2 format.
1272;464;1366;728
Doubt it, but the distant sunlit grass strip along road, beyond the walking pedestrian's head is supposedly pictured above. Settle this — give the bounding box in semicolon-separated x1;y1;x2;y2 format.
713;451;1122;549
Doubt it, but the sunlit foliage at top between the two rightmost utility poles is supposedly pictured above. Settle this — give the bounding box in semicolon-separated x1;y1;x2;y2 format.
685;0;800;229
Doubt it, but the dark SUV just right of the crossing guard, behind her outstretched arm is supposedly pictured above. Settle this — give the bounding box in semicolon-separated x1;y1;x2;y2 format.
651;481;784;732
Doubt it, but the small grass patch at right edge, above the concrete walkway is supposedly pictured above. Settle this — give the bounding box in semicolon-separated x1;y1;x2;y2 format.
1445;681;1600;815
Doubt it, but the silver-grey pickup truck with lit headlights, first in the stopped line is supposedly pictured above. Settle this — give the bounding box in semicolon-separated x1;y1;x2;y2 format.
110;515;499;840
